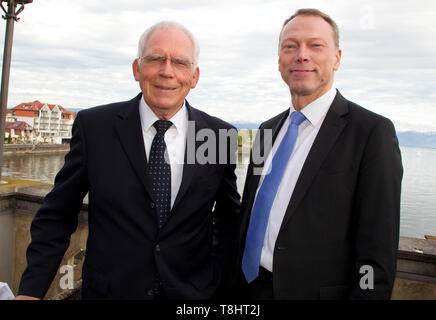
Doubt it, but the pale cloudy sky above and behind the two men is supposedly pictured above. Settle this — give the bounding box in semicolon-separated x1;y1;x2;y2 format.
0;0;436;131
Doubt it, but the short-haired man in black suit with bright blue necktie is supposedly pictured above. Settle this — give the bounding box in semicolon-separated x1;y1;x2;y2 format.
239;9;402;299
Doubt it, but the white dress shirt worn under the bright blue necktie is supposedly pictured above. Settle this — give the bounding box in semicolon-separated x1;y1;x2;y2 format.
256;84;336;271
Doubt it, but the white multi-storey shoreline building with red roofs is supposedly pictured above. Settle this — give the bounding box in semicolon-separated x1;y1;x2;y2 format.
6;100;77;144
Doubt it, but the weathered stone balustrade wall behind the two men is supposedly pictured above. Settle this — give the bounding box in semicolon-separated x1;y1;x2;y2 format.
0;186;436;300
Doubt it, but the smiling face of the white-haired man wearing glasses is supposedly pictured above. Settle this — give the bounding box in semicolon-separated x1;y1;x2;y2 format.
132;28;200;119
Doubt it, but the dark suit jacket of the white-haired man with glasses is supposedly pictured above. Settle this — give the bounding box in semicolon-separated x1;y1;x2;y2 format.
19;94;240;299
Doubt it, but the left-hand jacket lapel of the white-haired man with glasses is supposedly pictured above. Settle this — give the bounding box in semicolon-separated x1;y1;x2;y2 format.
115;94;154;199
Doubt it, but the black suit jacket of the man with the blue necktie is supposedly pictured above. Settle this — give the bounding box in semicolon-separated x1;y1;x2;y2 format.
239;92;403;299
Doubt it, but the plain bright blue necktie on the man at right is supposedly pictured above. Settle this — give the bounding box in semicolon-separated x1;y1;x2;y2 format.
242;112;306;283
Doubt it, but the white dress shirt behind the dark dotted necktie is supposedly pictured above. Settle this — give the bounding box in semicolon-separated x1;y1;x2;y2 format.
139;98;188;208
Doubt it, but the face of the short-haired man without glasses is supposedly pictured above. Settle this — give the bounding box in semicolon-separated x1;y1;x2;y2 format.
279;15;341;108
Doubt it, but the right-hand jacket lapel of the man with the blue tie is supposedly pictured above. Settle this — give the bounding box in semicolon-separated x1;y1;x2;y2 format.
280;91;348;230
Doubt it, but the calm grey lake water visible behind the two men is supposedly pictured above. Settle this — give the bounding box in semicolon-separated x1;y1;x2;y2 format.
2;147;436;238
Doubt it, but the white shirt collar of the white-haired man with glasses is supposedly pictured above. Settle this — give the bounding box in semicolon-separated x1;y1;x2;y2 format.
139;97;188;135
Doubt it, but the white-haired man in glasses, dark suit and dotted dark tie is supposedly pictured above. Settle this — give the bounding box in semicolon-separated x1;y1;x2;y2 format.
19;22;240;299
